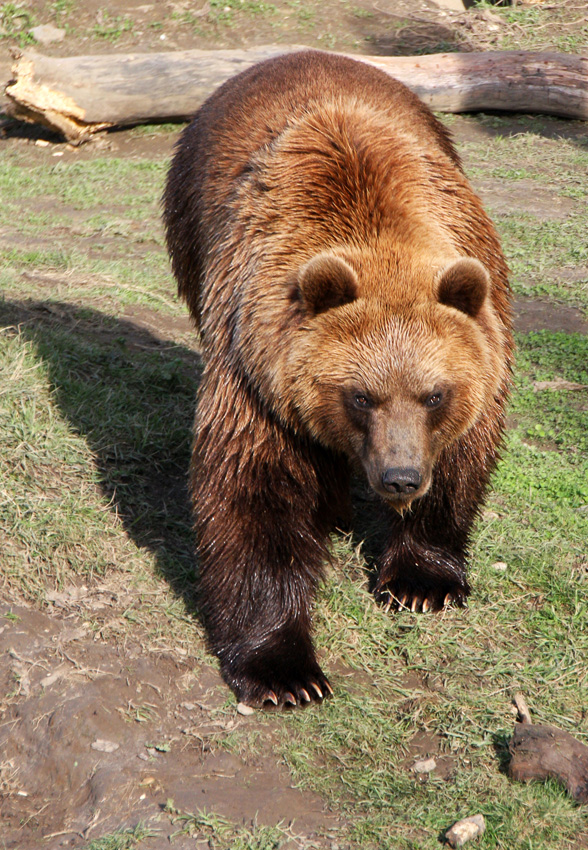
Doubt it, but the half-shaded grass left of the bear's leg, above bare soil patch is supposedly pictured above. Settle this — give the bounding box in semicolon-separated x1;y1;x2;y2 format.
0;305;198;595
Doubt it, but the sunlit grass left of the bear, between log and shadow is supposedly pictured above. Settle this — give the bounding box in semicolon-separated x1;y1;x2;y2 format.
0;155;179;315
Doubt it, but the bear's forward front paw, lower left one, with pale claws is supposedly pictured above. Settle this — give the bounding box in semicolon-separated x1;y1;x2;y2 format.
222;653;333;708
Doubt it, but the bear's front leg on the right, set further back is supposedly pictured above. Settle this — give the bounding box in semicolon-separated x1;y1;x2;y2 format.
375;432;499;611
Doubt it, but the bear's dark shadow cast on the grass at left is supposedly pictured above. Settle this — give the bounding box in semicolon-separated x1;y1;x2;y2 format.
0;301;201;613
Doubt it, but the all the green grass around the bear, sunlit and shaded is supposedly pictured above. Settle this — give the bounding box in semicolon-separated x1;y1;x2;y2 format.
0;114;588;850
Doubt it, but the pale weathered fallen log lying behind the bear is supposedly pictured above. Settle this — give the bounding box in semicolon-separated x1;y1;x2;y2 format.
6;47;588;143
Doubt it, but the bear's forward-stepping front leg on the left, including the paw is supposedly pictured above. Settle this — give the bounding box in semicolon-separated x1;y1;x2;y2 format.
192;366;347;705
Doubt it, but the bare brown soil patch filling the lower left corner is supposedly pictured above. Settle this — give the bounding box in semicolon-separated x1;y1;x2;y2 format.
0;600;333;850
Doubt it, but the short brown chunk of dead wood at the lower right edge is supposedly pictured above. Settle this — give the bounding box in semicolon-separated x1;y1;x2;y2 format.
508;723;588;803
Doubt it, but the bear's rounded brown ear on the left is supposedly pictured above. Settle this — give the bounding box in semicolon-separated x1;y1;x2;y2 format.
298;254;358;316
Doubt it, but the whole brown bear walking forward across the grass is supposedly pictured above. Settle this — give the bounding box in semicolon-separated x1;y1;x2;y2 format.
164;51;512;706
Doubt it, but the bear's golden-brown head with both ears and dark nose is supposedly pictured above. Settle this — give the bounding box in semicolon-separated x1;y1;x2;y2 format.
281;253;504;504
